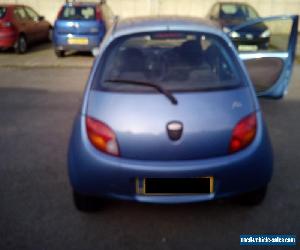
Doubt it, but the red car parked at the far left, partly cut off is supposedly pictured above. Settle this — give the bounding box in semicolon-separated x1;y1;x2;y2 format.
0;5;52;54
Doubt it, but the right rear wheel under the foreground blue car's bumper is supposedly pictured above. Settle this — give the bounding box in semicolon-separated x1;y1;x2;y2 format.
237;186;268;206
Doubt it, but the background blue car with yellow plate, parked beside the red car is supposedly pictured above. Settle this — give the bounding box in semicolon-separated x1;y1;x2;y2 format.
53;1;112;57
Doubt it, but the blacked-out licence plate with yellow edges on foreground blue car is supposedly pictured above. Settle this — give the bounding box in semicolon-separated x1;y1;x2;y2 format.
136;177;214;195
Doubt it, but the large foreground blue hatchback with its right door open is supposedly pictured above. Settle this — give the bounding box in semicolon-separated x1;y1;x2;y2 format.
68;16;298;211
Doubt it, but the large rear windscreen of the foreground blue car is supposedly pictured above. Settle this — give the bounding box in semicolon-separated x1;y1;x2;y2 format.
93;32;241;91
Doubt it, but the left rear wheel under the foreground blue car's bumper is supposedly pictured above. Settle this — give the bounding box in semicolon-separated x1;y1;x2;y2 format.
73;191;103;212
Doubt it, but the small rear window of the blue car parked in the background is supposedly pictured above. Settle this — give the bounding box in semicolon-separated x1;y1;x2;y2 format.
59;6;96;20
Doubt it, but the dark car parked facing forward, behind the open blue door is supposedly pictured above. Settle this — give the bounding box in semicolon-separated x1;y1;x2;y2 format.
208;2;271;50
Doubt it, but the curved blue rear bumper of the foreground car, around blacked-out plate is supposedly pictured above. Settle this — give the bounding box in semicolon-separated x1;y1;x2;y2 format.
68;112;273;203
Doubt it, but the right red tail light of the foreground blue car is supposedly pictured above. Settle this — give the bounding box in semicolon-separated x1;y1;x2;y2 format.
229;113;257;153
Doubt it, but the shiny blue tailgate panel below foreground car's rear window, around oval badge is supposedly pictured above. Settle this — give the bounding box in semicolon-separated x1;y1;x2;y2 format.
87;87;254;161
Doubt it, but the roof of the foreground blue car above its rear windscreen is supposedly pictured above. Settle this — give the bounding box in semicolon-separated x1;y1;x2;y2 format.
115;15;220;32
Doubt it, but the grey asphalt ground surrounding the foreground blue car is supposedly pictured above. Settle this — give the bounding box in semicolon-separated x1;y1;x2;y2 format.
0;44;300;250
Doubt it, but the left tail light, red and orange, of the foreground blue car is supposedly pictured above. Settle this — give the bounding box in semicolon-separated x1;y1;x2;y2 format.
86;117;120;156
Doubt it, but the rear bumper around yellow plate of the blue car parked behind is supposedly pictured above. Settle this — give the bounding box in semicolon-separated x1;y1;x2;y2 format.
53;32;104;51
